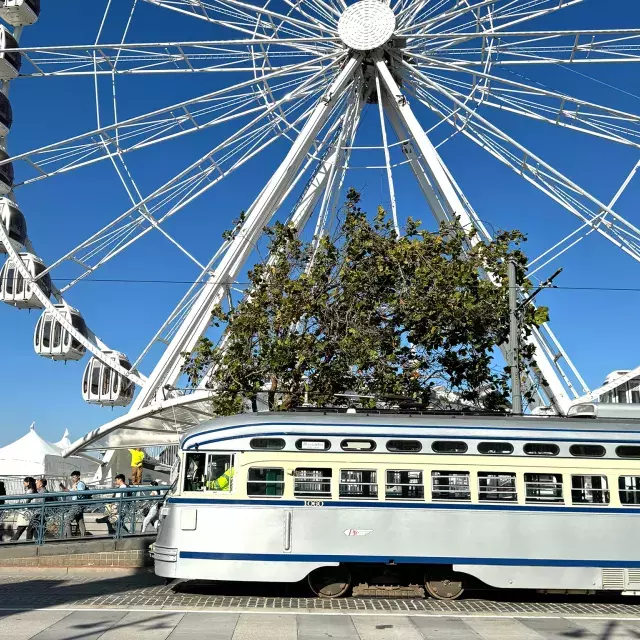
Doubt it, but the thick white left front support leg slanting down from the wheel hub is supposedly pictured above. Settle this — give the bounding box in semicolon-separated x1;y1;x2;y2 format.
131;56;361;404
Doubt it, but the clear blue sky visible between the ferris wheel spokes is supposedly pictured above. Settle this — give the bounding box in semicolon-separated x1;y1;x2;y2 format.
0;0;640;445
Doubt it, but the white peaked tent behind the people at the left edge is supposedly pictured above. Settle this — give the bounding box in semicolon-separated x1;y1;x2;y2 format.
0;423;100;477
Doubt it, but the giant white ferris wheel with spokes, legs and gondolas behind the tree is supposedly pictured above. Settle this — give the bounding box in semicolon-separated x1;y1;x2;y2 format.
0;0;640;456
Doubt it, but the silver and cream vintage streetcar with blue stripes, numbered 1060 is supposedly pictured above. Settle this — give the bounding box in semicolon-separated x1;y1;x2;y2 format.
154;405;640;599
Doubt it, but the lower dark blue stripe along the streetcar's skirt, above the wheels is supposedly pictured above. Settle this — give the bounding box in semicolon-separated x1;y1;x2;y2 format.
180;551;640;569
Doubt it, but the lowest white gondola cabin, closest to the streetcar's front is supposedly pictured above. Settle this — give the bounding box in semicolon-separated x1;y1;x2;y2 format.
82;351;135;407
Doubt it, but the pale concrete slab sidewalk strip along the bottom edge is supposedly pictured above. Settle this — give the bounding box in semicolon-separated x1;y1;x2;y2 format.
0;609;640;640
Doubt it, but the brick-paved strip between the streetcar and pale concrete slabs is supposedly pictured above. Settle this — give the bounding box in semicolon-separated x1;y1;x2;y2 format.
0;570;640;616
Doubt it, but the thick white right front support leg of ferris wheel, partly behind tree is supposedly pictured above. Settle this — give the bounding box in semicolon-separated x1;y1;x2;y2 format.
376;57;571;414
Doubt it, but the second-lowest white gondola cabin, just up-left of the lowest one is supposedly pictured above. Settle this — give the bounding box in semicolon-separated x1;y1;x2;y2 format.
33;304;87;360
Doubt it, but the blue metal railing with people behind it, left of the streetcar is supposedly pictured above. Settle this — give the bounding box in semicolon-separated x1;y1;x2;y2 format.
0;486;170;544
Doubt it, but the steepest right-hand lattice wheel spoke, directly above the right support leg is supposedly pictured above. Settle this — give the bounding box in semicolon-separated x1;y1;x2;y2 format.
406;65;640;261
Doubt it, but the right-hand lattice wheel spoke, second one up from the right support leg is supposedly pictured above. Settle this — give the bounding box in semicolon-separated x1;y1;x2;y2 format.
414;54;640;146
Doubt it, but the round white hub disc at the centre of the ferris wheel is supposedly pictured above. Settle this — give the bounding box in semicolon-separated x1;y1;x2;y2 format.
338;0;396;51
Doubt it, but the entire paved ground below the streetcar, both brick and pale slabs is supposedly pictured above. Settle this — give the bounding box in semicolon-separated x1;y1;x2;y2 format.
0;571;640;640
